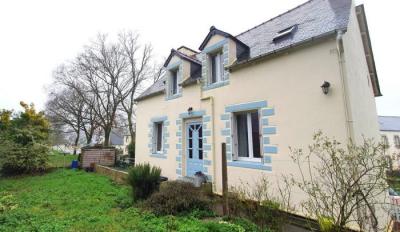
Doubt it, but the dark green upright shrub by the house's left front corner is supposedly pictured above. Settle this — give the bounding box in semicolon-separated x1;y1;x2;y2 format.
128;163;161;201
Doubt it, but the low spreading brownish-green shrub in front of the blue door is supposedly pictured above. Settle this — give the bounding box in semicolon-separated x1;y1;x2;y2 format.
144;181;210;215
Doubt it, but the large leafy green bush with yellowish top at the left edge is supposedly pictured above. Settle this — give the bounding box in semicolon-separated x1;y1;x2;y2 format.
0;102;50;175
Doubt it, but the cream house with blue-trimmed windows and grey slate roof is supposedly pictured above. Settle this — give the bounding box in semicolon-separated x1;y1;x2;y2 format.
136;0;381;225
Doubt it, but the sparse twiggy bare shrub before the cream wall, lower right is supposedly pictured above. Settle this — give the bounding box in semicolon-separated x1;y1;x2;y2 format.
291;132;387;231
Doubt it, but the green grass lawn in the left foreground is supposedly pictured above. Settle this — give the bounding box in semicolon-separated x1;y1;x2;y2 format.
0;169;248;232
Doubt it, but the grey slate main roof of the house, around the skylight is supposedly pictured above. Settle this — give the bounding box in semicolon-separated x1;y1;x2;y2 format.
137;0;352;100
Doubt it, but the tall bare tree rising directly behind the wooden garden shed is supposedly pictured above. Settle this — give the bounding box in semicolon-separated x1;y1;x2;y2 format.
70;35;128;146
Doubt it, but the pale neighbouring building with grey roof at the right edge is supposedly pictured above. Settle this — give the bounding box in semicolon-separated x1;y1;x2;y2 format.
379;116;400;169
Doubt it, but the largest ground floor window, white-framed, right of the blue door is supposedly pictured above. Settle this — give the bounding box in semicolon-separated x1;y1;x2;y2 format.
233;111;261;161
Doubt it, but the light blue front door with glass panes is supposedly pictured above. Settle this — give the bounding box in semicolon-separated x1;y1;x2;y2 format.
186;122;203;176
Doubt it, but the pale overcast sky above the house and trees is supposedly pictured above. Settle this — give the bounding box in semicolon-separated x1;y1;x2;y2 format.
0;0;400;116
